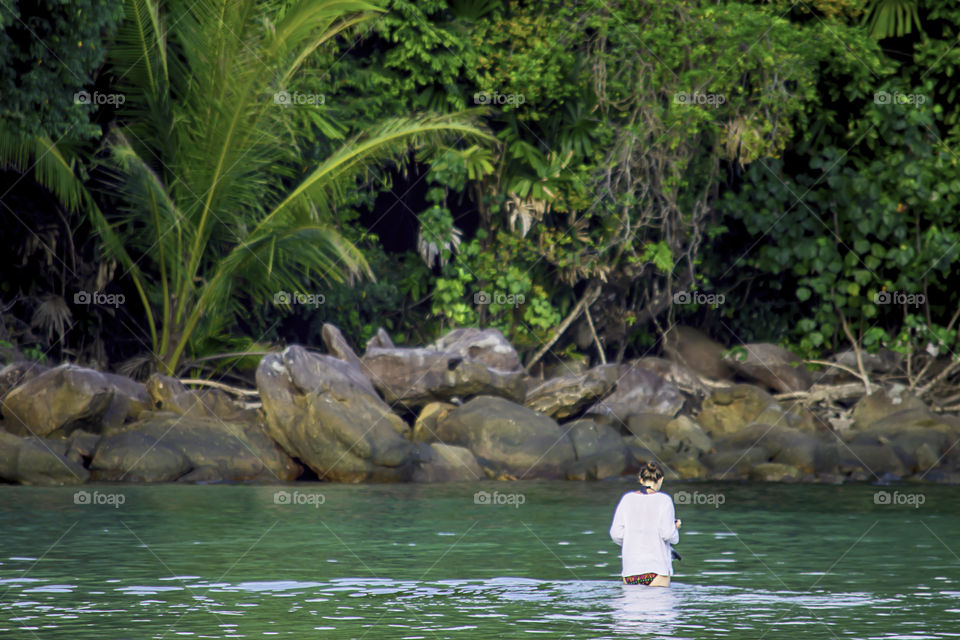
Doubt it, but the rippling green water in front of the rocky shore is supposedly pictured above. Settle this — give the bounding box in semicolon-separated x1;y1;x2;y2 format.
0;482;960;640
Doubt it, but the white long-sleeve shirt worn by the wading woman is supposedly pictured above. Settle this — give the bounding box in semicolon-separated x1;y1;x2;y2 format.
610;491;680;576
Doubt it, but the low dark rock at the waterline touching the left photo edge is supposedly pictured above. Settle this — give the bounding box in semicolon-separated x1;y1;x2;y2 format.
0;430;90;486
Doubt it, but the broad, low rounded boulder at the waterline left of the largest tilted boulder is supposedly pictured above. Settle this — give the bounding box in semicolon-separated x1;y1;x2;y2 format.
90;413;301;482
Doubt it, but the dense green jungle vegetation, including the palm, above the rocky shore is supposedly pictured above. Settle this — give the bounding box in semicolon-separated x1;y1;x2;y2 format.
0;0;960;380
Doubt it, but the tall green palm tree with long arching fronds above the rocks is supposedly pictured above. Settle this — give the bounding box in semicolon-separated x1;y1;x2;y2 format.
0;0;488;373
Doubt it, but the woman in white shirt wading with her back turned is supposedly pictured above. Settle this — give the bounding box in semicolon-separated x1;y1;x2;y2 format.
610;462;680;587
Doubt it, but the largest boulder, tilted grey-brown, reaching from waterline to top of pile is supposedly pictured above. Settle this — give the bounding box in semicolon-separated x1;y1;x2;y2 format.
257;346;417;482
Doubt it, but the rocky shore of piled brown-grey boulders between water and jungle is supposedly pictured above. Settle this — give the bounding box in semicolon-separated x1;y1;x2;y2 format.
0;325;960;485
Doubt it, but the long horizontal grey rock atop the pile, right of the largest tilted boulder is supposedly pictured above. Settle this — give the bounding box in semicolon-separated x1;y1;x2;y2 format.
363;348;526;409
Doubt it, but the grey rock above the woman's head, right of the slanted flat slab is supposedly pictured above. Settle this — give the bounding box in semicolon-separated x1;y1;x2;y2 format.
585;365;684;427
